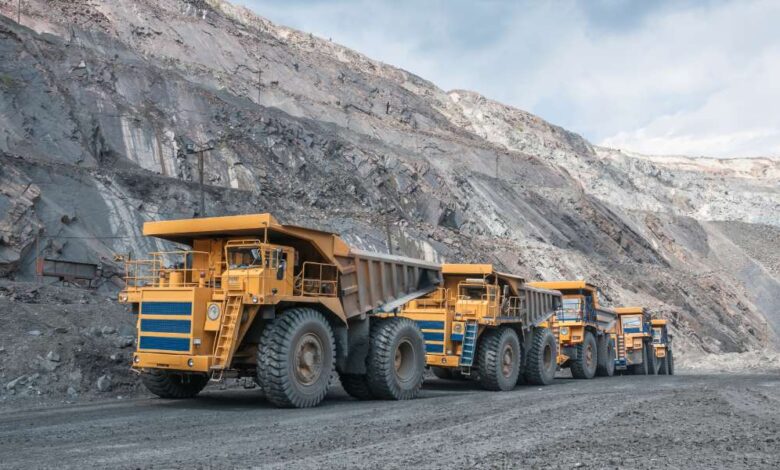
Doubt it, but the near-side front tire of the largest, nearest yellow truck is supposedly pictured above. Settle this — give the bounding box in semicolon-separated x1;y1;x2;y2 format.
257;307;336;408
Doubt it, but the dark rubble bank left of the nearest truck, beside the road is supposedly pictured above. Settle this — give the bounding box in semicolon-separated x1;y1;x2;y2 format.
0;281;140;403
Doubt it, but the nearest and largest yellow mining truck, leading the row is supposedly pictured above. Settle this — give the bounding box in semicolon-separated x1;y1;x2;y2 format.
119;214;441;407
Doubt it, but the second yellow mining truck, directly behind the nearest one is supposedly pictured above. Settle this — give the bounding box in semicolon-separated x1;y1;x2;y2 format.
400;264;561;390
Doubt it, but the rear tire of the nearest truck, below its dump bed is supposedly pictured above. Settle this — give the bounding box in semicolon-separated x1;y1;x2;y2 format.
366;317;425;400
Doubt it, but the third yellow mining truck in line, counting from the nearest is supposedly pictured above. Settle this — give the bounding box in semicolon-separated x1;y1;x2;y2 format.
529;281;617;379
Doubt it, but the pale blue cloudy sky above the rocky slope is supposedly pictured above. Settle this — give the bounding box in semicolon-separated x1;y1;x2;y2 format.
239;0;780;157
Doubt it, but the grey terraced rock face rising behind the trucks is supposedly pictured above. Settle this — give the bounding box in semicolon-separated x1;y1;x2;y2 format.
0;0;780;362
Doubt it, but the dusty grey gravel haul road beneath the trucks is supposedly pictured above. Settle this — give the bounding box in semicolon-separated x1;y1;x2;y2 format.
0;375;780;469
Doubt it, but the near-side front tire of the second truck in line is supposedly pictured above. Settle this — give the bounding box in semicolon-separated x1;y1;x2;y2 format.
477;327;520;391
